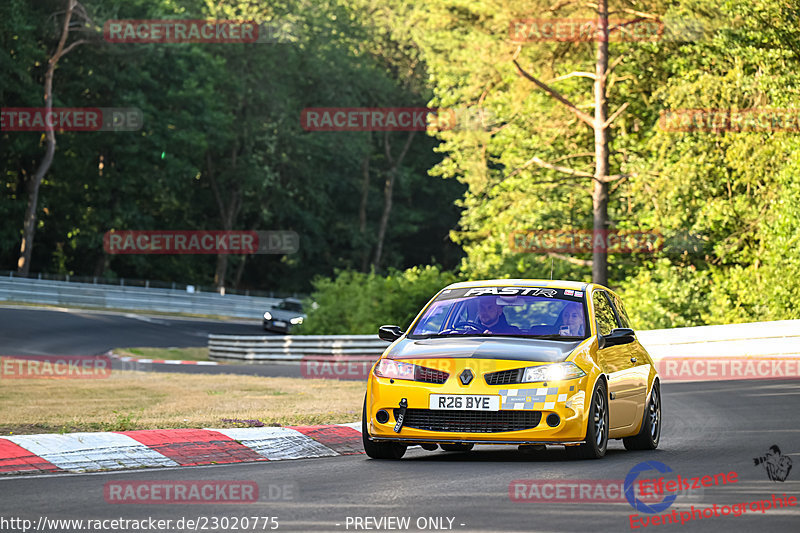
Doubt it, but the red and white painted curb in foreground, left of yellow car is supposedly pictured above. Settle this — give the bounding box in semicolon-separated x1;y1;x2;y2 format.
0;422;364;474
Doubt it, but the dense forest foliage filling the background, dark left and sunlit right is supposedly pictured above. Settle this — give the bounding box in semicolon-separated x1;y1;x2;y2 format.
0;0;800;333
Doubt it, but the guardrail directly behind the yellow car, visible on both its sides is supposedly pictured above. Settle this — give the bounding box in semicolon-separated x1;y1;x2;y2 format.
208;320;800;363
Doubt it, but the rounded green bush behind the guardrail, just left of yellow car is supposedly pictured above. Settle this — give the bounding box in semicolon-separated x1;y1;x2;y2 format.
295;266;457;335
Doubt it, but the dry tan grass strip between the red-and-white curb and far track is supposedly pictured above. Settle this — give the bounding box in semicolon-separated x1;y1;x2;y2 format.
0;371;364;436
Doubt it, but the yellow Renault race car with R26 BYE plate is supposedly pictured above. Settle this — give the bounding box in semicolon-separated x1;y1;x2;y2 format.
362;279;661;459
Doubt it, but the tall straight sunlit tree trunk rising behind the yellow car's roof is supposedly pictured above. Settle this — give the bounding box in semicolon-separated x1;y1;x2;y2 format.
592;0;609;285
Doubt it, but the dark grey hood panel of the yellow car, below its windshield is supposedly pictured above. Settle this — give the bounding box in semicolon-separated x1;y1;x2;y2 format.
387;337;583;363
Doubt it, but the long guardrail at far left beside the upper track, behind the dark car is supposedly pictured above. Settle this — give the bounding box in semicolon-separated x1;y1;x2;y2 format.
0;277;279;319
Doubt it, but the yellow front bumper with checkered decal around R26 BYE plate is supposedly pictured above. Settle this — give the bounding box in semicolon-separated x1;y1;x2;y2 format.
367;359;593;444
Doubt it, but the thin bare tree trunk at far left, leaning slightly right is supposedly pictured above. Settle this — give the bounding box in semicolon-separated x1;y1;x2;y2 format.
17;0;84;276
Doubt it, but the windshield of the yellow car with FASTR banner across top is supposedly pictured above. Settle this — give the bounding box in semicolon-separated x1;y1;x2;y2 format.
409;287;587;340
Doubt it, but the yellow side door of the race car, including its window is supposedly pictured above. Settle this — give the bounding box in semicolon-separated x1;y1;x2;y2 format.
592;289;641;430
